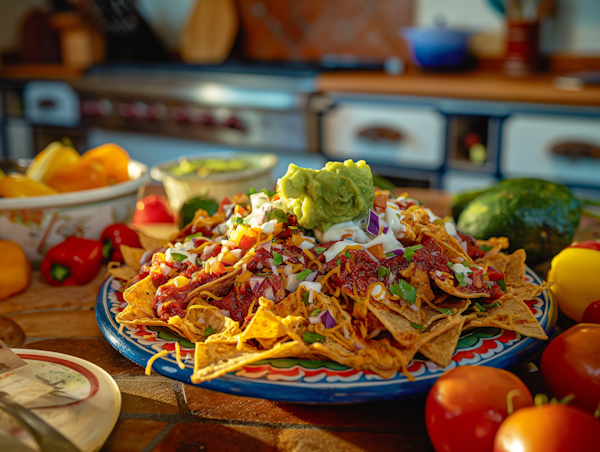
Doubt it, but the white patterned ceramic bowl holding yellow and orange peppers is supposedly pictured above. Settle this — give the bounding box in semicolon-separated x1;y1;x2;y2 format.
0;161;150;265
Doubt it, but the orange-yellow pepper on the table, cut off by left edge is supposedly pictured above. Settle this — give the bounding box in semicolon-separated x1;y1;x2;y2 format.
0;240;31;300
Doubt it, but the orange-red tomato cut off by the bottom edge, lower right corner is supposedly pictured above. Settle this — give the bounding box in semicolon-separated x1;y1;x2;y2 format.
494;404;600;452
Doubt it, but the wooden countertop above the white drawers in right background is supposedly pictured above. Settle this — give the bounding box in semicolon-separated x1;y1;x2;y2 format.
317;72;600;107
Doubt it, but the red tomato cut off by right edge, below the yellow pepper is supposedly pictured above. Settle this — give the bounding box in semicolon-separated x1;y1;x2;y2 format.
541;323;600;414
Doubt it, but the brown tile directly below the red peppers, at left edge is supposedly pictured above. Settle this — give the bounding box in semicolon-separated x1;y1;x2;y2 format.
0;268;106;315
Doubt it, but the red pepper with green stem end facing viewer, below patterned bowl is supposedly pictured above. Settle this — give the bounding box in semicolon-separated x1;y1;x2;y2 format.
40;237;102;286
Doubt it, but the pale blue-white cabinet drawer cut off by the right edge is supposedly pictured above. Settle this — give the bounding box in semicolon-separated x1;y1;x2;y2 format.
501;115;600;186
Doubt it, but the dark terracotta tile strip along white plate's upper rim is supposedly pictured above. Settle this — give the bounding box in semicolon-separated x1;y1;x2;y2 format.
25;338;144;375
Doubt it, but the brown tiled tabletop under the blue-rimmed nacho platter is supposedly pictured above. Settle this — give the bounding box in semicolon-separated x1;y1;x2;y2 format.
0;189;600;452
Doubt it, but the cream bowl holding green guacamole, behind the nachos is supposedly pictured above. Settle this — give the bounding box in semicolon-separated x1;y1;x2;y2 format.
150;151;277;212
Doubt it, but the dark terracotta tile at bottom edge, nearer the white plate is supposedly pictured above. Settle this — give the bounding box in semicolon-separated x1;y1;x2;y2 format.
152;424;279;452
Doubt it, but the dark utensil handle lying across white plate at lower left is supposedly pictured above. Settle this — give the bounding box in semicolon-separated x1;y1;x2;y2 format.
0;392;81;452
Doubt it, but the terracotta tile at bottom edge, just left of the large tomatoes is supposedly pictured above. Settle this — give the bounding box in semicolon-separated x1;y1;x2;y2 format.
277;429;433;452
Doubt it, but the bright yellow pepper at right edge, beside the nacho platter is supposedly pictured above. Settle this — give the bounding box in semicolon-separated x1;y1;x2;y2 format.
548;240;600;322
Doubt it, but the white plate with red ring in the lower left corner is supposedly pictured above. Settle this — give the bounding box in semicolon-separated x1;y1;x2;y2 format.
3;349;121;452
